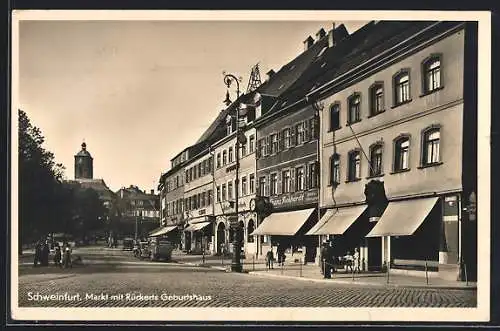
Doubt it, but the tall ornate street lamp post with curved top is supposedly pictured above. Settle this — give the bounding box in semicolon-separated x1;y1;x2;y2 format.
224;73;242;272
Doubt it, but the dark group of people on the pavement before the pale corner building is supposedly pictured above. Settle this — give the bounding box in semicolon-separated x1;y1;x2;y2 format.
320;241;361;278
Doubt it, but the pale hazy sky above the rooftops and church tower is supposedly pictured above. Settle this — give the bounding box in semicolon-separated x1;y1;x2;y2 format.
19;20;367;191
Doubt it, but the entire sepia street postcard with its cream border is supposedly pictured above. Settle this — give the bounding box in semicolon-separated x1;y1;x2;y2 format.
10;10;491;322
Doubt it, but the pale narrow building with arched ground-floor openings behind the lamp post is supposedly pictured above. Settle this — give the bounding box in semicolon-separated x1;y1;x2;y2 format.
212;93;257;256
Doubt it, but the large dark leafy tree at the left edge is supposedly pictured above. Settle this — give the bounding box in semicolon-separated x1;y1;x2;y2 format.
18;110;65;254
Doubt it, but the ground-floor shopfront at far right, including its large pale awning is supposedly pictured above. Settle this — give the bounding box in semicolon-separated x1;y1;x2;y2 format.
367;195;460;280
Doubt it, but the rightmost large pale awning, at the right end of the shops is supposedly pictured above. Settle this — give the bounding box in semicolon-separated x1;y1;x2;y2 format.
367;197;439;237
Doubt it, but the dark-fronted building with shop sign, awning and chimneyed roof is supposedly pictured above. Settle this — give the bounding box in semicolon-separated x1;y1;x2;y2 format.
254;25;348;262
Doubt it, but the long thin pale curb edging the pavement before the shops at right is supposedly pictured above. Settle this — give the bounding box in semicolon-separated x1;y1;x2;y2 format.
248;271;477;290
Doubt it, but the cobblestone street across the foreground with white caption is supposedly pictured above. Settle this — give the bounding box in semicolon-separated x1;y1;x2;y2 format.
19;246;476;307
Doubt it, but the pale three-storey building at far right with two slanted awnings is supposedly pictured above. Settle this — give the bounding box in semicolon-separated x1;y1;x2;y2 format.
306;21;477;279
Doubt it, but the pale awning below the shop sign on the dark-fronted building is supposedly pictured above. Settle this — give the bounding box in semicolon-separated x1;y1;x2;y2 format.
251;208;315;236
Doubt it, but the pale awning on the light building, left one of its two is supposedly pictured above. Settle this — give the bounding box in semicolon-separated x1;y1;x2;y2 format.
308;205;368;235
